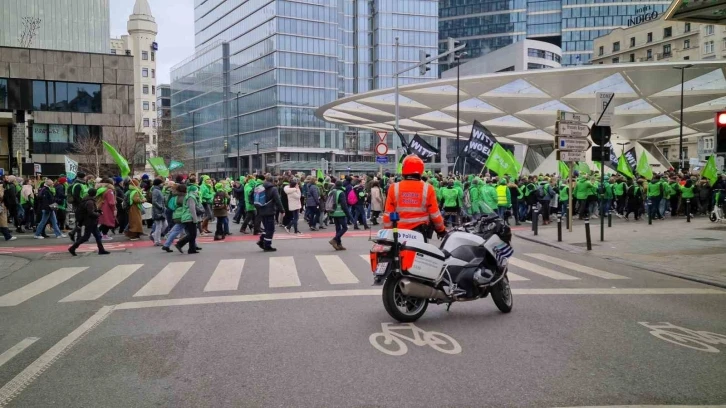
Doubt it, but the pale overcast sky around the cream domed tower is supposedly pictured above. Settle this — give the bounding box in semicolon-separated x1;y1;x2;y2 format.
109;0;194;84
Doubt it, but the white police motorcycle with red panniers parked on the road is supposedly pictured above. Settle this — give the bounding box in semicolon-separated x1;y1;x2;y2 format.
370;206;514;322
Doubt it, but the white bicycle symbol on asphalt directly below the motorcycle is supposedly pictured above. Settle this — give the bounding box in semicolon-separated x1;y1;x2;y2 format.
368;323;461;356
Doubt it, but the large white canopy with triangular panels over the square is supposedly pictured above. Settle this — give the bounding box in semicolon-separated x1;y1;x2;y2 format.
316;61;726;148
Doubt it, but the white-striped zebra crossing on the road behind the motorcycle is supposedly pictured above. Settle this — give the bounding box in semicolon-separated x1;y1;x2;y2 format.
0;253;630;307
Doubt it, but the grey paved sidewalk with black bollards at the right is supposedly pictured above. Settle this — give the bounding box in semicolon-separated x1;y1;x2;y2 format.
514;217;726;288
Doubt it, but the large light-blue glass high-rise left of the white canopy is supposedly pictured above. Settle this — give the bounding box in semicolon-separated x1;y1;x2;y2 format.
171;0;438;173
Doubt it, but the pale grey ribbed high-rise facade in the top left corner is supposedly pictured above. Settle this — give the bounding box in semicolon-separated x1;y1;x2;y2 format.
0;0;111;53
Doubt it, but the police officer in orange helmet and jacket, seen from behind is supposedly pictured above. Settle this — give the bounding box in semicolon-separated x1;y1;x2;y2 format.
383;155;446;237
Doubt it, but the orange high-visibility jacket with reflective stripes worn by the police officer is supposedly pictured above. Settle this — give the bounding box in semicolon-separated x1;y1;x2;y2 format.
383;180;444;231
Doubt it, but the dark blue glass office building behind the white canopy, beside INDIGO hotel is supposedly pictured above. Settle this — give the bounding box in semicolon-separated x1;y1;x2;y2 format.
439;0;670;71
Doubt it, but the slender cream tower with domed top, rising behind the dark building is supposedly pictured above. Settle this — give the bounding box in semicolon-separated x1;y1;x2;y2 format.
110;0;158;163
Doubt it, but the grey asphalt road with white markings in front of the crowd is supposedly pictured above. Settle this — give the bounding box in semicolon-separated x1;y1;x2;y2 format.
0;230;726;407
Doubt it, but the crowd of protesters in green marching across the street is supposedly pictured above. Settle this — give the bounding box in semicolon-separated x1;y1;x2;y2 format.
0;167;726;255
